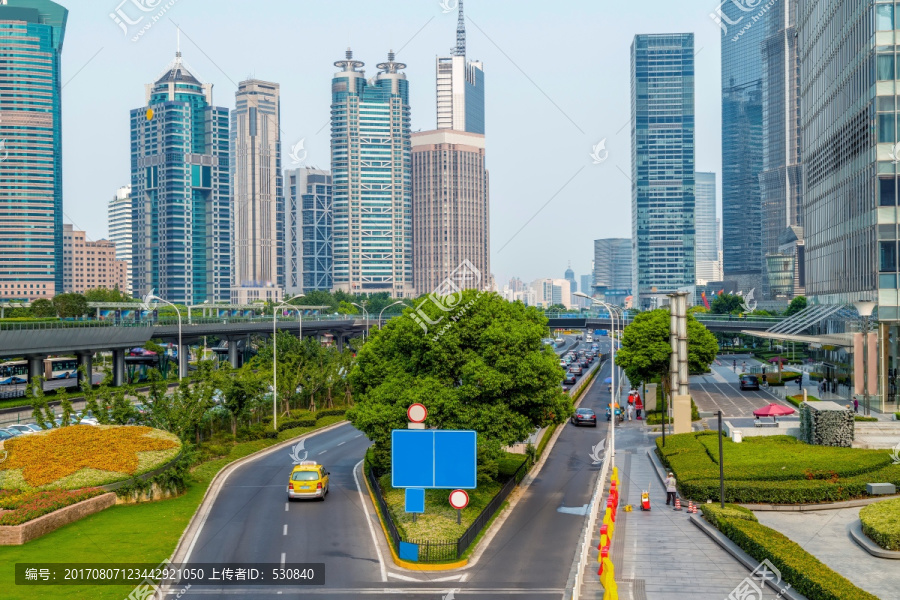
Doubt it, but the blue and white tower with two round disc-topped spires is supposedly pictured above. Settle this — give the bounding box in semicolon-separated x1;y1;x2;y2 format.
331;49;414;298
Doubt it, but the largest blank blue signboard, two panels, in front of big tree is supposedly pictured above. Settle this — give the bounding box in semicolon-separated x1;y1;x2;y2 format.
391;429;477;490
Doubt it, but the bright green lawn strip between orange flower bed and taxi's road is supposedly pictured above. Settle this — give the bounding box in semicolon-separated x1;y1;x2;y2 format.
0;416;344;600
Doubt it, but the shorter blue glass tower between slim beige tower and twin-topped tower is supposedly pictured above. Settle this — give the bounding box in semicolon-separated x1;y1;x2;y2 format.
284;167;334;296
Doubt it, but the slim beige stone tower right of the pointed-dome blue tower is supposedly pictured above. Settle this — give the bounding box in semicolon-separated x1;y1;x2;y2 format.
230;79;284;304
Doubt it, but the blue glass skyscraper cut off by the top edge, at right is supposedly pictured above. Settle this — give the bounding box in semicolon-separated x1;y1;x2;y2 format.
719;2;774;298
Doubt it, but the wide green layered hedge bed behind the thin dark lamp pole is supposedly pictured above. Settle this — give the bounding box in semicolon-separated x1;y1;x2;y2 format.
656;431;900;504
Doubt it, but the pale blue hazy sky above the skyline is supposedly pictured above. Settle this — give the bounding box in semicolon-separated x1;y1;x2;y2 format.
57;0;721;288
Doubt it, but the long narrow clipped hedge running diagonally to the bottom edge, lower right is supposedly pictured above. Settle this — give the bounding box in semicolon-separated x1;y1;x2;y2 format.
700;504;878;600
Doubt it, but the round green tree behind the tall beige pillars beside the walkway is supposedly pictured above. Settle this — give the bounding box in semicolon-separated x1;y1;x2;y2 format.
616;308;719;392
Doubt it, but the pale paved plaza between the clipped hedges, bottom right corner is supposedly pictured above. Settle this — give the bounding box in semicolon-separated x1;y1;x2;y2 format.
755;508;900;600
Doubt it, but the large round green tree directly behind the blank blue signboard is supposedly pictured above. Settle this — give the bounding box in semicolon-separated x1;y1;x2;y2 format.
348;291;572;469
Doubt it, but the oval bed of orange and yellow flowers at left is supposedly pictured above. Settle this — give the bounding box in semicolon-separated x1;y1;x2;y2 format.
0;425;181;490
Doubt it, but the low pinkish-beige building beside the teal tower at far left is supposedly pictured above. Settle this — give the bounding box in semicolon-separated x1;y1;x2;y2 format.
63;223;128;294
